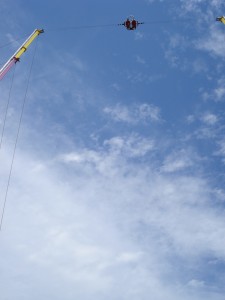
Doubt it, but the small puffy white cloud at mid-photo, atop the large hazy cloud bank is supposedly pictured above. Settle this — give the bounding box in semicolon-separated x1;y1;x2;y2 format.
57;135;155;177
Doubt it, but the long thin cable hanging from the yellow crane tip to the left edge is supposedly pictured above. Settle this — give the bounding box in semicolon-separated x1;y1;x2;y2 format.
0;42;37;232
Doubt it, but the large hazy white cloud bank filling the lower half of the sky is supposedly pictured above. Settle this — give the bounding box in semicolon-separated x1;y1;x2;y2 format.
1;132;225;300
